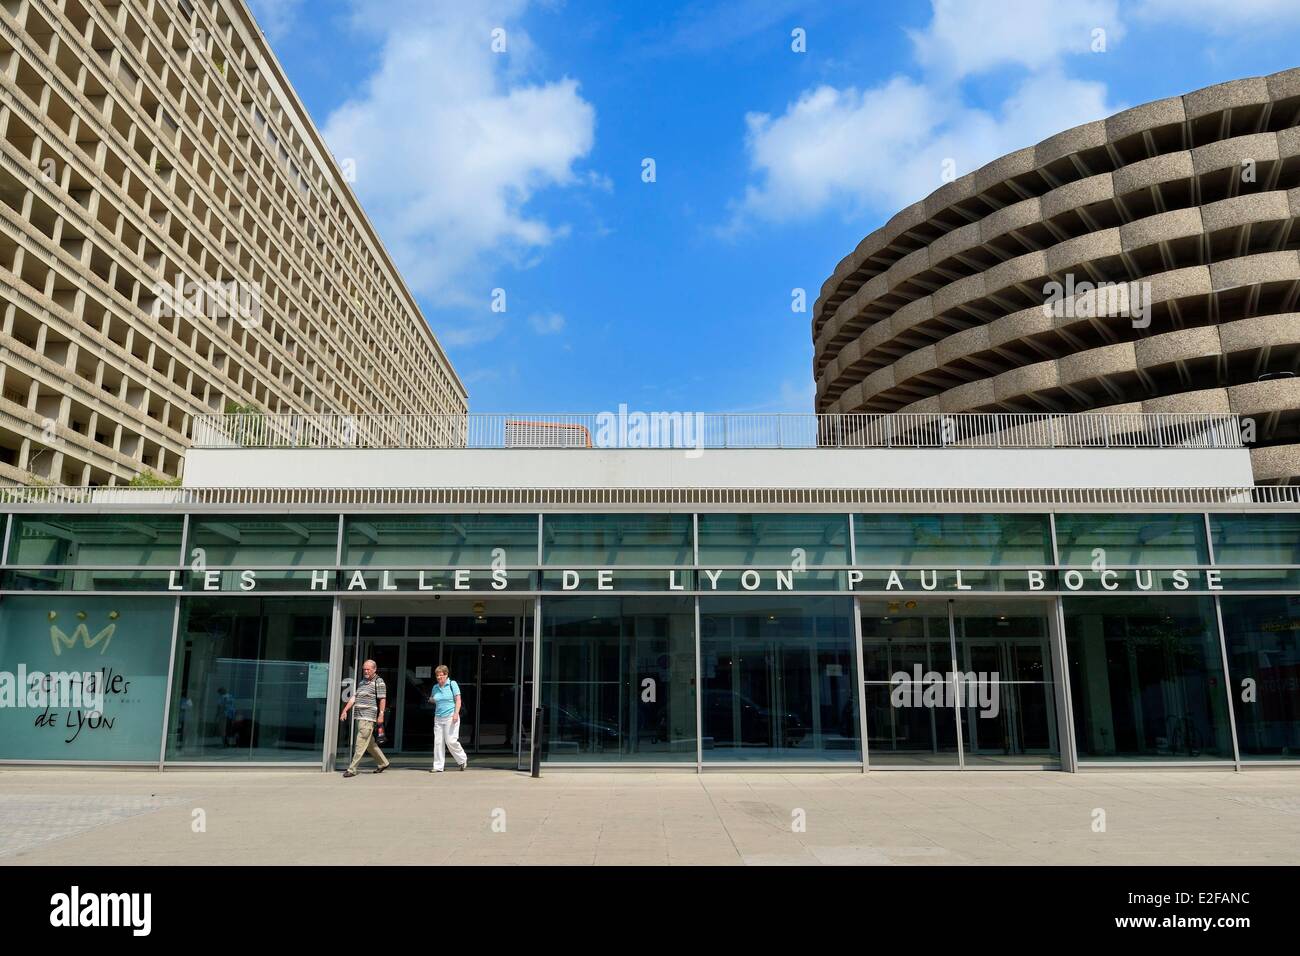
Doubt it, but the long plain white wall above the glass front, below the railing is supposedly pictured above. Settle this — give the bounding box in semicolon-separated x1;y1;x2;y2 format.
185;449;1253;488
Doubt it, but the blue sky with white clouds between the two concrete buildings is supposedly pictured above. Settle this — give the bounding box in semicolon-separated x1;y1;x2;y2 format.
251;0;1300;412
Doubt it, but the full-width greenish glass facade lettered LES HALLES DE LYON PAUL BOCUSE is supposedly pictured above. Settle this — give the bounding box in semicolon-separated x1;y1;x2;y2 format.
0;506;1300;769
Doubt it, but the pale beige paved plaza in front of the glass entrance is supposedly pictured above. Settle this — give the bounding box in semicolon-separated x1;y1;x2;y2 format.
0;767;1300;865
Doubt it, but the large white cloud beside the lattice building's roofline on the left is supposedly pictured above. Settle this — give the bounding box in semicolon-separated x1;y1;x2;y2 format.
324;0;595;304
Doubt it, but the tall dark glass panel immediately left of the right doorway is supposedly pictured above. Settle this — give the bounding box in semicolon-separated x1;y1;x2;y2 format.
699;597;862;761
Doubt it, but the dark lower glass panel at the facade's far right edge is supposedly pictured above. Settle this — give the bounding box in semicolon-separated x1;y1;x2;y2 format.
1222;595;1300;760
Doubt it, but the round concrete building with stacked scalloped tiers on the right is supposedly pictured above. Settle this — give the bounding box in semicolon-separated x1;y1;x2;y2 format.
813;69;1300;483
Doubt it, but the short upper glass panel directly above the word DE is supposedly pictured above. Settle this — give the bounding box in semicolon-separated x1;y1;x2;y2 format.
542;514;694;567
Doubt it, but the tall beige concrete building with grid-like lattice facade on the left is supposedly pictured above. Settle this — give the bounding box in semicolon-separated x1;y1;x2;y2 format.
0;0;467;484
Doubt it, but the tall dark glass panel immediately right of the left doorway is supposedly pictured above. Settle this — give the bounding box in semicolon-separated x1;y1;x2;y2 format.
542;597;696;761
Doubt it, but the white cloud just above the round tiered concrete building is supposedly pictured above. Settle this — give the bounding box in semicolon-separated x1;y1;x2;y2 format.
720;0;1122;227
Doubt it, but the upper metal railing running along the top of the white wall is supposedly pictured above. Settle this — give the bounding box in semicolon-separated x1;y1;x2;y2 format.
192;410;1244;449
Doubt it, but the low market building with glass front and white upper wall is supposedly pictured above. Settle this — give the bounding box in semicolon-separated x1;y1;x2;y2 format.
0;414;1300;773
